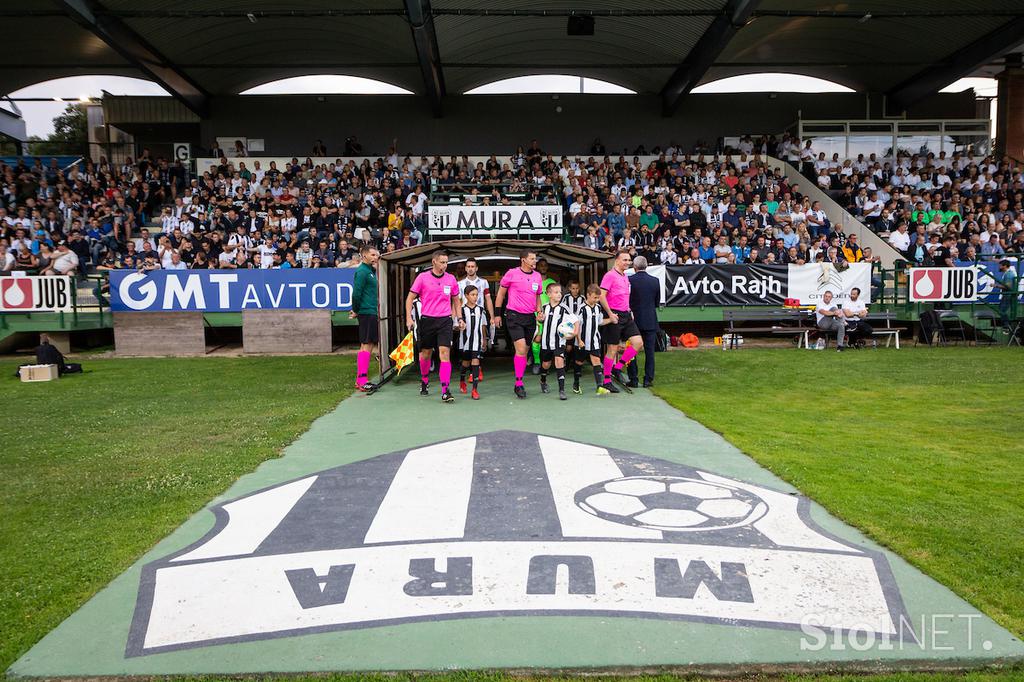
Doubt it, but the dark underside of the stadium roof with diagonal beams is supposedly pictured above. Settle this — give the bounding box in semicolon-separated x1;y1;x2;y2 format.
6;0;1024;115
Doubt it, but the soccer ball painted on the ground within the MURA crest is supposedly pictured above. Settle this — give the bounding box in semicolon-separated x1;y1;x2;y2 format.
575;476;768;531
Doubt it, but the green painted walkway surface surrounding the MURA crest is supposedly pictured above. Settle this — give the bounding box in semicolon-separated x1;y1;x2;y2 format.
9;372;1024;676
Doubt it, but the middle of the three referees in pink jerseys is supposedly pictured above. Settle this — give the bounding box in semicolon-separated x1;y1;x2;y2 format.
495;249;543;399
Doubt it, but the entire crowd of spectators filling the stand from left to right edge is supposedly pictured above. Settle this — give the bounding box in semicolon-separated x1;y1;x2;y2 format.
0;136;1024;273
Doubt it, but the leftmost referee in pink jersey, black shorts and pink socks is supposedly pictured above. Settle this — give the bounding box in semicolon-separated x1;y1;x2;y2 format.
406;251;465;402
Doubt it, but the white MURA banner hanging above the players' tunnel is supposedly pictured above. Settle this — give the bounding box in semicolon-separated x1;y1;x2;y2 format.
427;206;562;235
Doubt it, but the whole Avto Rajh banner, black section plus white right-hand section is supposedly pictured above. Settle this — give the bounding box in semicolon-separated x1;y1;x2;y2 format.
664;263;871;305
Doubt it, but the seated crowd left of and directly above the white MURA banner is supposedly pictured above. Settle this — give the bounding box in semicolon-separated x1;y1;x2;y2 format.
0;143;556;273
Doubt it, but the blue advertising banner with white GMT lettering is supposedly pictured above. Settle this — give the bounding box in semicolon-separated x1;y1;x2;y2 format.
111;268;355;312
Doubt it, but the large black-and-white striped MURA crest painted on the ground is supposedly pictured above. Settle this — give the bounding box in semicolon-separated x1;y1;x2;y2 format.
126;431;905;656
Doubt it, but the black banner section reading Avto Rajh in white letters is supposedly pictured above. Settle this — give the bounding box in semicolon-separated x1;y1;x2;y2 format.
665;264;790;305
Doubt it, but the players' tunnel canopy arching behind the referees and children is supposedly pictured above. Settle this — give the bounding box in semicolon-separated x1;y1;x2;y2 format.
378;240;611;371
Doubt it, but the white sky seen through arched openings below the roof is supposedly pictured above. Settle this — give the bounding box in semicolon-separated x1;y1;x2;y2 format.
10;74;995;138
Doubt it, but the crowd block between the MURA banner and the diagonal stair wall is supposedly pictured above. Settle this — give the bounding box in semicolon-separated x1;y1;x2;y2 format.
559;151;877;274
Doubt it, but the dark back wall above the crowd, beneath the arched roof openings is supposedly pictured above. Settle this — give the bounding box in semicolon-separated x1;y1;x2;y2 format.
195;91;975;157
